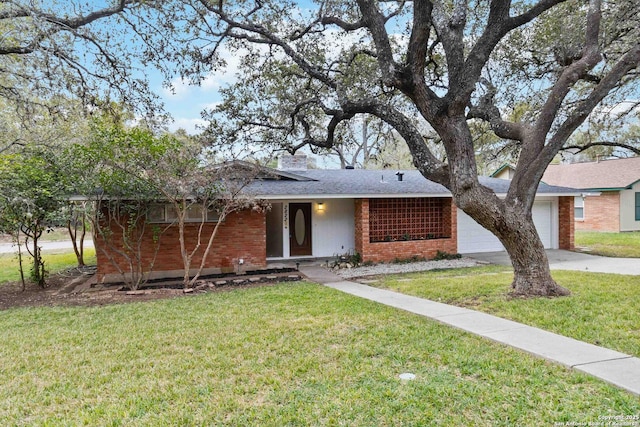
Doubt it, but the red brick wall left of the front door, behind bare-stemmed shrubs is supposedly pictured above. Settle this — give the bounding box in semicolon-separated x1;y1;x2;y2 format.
94;210;267;282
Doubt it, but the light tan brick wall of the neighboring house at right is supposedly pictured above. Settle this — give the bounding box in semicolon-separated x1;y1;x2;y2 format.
576;191;620;232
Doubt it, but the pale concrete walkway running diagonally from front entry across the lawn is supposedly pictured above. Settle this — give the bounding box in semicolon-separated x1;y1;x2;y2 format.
300;265;640;395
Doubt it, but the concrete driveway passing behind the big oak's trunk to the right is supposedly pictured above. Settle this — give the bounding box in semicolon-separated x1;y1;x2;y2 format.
465;249;640;276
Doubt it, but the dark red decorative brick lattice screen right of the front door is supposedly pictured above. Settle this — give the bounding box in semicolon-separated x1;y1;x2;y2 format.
369;198;451;243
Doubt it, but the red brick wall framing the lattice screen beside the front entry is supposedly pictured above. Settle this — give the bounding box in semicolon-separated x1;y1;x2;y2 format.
355;199;458;262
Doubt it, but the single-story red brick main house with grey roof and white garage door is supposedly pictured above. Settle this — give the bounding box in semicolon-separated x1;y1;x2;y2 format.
96;156;579;281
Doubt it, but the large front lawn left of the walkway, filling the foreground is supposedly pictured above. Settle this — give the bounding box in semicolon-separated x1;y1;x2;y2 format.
0;282;640;426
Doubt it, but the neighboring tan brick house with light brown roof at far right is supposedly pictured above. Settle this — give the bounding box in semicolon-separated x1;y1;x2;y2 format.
542;157;640;232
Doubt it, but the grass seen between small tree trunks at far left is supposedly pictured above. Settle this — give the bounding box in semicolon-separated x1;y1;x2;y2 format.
0;248;96;284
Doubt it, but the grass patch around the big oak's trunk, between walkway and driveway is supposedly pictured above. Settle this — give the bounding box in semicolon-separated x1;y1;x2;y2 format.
374;266;640;356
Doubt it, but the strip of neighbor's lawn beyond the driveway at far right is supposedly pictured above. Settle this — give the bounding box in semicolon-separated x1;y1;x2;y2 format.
575;231;640;258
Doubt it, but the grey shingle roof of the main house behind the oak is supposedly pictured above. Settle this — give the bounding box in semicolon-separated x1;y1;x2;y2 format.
247;169;579;199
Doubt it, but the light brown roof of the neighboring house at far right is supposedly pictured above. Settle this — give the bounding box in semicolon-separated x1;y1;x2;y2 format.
542;157;640;191
